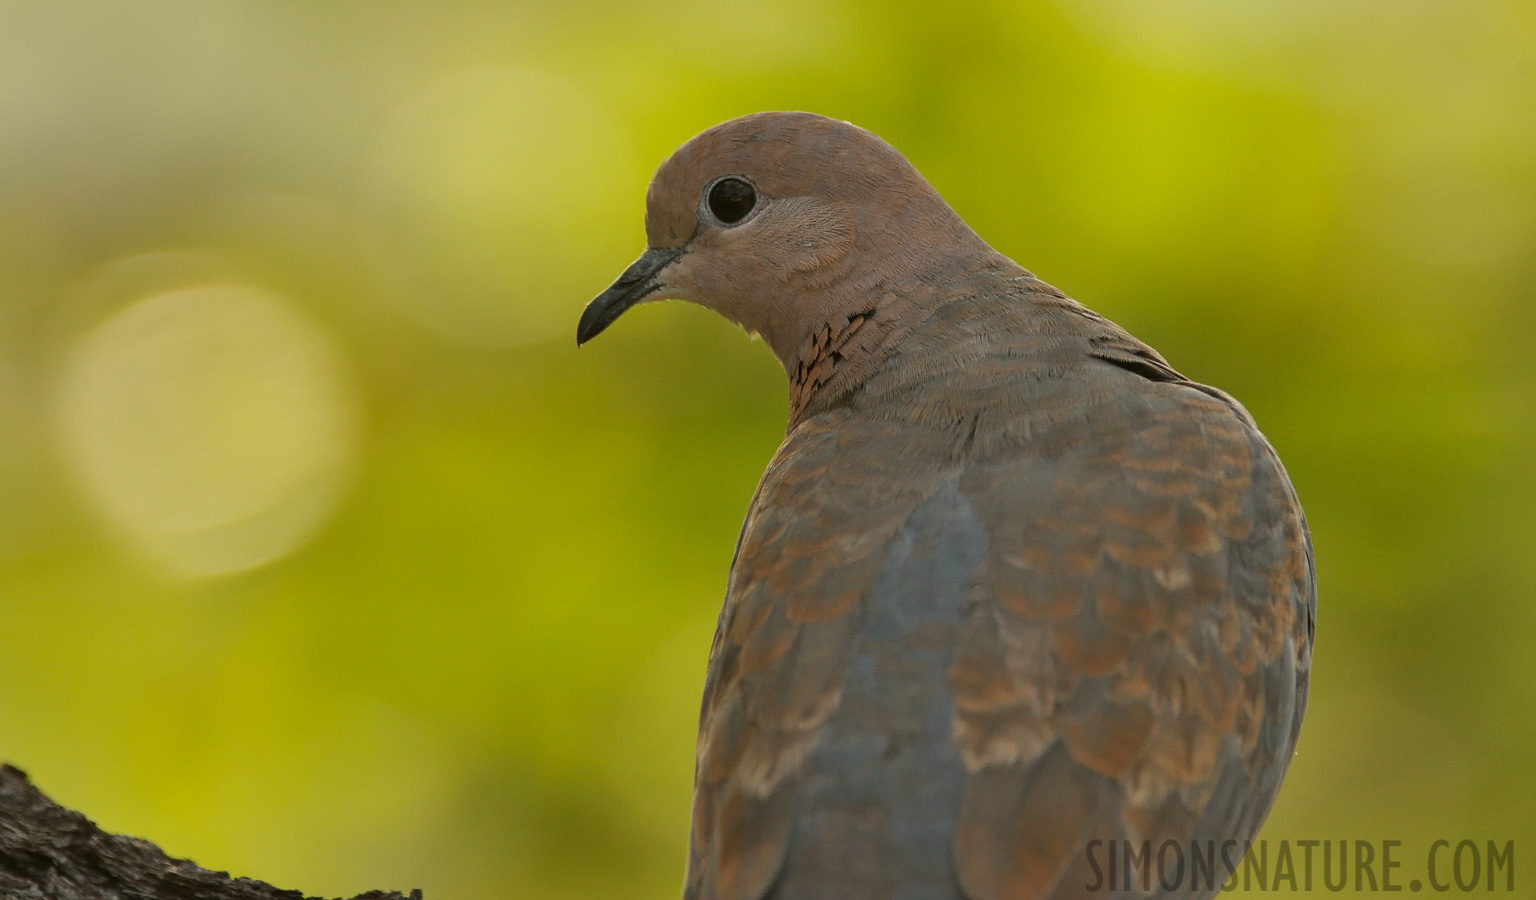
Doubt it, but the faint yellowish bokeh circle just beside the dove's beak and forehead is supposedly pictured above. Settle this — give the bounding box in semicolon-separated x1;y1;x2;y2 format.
364;66;645;346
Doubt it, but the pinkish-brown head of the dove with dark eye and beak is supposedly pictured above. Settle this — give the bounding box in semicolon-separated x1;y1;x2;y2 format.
576;112;985;369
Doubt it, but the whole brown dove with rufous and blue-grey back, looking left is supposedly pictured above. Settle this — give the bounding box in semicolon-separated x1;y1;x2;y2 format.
578;112;1316;900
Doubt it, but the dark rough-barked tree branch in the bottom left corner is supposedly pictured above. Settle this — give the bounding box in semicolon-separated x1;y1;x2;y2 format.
0;765;421;900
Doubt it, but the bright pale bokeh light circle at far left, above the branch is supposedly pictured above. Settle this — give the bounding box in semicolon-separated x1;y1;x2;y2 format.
58;284;356;577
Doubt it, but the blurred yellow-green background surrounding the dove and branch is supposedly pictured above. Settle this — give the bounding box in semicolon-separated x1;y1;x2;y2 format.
0;0;1536;900
